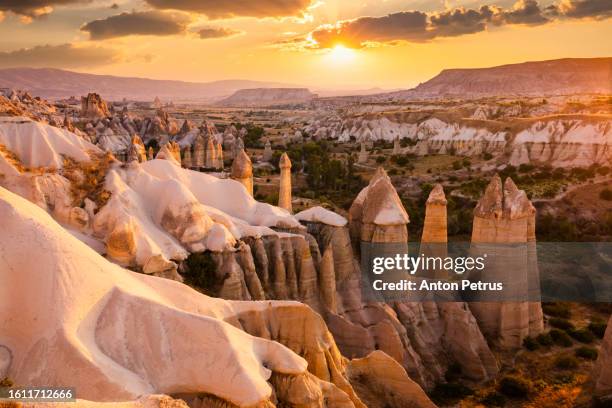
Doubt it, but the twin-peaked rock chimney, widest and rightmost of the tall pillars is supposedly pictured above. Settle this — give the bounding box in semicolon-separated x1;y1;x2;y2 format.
470;175;544;348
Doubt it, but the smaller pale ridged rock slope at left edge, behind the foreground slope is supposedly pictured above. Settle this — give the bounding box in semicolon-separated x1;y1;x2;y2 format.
0;117;101;169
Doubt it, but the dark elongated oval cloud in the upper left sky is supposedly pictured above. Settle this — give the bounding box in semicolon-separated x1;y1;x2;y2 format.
81;10;191;40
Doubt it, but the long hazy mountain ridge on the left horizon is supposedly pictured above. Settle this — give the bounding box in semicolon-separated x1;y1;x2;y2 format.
0;68;298;101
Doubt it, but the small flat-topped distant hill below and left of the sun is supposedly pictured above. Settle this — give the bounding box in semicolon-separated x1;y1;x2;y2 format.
218;88;317;106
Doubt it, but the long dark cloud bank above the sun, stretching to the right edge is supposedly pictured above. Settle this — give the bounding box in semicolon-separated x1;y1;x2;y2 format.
308;0;612;49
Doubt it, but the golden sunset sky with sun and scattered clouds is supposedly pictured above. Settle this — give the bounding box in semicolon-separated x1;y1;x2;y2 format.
0;0;612;90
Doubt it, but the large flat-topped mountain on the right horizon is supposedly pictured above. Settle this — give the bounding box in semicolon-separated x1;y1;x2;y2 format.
380;58;612;98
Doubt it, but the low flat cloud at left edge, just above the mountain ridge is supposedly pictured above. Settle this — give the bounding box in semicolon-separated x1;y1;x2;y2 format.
0;44;123;68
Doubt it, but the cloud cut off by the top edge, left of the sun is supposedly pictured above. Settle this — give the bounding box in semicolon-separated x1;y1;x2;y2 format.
145;0;311;19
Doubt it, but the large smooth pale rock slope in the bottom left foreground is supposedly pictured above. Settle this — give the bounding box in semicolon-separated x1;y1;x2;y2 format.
0;188;307;406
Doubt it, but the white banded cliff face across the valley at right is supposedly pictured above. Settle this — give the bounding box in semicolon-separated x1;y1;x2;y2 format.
304;113;612;167
